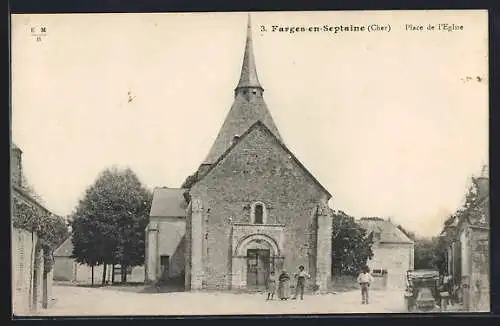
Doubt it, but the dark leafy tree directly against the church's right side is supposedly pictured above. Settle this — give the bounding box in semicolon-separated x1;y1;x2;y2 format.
332;211;373;275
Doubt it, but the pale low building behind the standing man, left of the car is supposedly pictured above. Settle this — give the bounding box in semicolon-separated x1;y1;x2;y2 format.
358;217;415;289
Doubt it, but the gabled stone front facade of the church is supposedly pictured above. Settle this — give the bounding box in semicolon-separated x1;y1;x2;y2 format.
190;123;332;290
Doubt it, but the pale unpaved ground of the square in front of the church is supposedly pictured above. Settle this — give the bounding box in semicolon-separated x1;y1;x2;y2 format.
33;285;412;316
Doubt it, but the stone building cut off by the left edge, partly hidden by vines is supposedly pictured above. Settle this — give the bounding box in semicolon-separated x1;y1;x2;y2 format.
11;144;53;315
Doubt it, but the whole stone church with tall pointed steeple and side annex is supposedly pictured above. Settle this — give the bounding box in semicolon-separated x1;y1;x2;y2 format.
145;17;333;291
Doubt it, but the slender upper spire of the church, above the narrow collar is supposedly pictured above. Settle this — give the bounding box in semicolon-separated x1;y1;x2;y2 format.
235;14;264;95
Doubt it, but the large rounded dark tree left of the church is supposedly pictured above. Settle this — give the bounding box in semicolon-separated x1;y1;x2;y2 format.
71;167;152;283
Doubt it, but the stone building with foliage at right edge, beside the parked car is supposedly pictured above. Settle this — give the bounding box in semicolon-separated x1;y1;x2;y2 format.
440;166;490;312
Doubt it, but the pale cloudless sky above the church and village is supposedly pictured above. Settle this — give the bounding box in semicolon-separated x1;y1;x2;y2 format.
11;11;488;236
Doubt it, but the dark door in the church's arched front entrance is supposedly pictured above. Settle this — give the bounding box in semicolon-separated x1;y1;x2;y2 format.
247;249;270;290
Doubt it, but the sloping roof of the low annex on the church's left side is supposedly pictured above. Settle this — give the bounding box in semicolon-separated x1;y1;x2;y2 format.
149;187;187;217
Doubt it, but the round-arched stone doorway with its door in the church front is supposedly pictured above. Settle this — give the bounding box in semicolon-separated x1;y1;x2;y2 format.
232;234;283;290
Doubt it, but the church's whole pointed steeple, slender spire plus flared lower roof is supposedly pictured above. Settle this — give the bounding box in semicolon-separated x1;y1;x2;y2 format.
202;15;283;166
